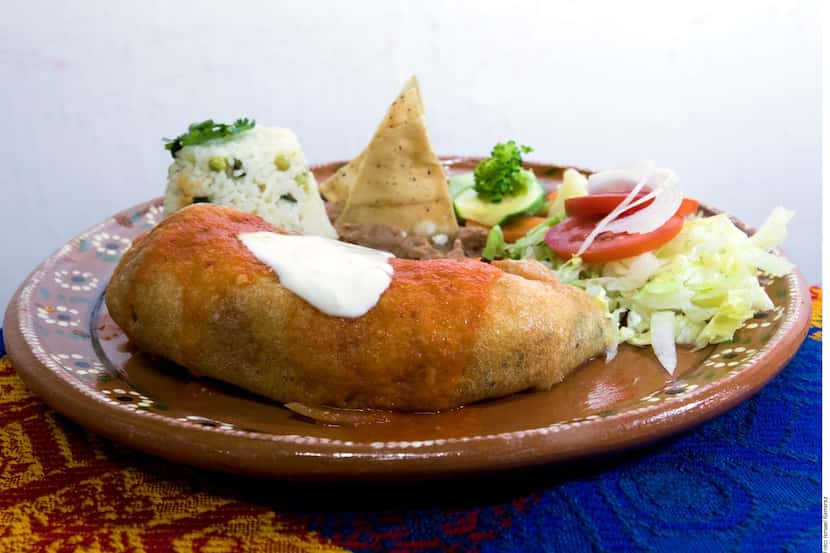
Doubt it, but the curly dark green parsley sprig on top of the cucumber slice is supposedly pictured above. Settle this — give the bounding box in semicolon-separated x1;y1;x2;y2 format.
473;140;533;203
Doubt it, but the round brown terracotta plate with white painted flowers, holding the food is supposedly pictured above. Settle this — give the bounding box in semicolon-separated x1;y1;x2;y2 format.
5;159;809;478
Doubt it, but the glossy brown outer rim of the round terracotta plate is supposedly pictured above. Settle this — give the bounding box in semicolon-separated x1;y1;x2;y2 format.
3;156;810;479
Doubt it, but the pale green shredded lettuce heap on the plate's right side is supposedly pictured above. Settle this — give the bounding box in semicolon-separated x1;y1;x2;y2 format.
513;207;793;372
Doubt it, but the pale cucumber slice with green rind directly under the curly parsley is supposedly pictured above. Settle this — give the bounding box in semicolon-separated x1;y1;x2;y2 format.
450;173;545;226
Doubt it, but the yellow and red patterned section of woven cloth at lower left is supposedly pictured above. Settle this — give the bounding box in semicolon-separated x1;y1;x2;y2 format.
0;357;345;553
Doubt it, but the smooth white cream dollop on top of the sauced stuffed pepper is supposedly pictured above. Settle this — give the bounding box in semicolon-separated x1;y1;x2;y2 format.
239;232;395;318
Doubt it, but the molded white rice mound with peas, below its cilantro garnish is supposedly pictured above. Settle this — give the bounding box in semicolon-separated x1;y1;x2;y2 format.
164;125;337;238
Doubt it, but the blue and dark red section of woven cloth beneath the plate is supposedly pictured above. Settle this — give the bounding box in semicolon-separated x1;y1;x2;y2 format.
0;289;821;553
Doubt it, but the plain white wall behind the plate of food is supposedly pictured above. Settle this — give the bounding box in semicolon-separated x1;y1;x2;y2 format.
0;0;821;307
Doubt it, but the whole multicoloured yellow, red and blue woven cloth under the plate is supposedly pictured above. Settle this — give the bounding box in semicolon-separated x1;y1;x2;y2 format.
0;287;822;553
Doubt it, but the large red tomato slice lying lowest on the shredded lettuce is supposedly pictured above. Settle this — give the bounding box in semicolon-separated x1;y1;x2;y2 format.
545;215;683;263
